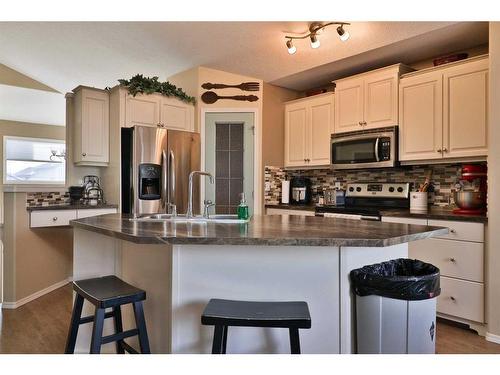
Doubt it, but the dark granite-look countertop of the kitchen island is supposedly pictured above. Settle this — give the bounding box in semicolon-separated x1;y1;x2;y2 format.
70;214;448;247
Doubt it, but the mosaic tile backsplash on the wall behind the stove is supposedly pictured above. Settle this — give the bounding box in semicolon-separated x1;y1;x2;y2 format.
264;164;478;206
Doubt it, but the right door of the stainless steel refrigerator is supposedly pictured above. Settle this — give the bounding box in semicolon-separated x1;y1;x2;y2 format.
165;130;201;214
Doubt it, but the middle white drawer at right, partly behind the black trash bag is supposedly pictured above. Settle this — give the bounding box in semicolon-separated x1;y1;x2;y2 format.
411;238;484;282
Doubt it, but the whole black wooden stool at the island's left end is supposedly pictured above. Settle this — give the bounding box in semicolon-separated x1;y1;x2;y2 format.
65;276;150;354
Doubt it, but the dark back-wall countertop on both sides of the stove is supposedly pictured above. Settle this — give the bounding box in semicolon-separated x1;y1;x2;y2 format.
266;203;488;223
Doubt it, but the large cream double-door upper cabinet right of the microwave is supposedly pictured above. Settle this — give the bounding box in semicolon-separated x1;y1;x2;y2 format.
399;57;488;161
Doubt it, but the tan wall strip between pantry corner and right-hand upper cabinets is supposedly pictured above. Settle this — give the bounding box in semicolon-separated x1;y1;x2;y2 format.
262;83;299;167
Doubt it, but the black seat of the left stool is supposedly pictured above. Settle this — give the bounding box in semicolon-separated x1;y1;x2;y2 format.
73;276;146;309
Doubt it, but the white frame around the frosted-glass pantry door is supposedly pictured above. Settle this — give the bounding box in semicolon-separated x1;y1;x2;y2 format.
200;107;263;215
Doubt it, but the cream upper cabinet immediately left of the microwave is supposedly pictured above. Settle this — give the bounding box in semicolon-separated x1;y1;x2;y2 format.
284;93;334;167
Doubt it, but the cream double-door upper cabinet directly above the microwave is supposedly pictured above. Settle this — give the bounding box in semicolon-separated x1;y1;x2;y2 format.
335;64;412;133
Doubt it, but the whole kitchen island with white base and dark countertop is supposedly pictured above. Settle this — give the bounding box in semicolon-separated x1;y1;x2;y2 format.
71;214;448;353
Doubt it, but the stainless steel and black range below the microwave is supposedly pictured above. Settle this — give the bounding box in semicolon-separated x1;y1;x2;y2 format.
316;182;410;220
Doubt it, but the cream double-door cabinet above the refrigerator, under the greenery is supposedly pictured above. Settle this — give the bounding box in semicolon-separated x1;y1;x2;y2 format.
125;93;194;131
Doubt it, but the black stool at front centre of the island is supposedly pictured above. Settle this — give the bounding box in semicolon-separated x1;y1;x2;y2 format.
201;299;311;354
